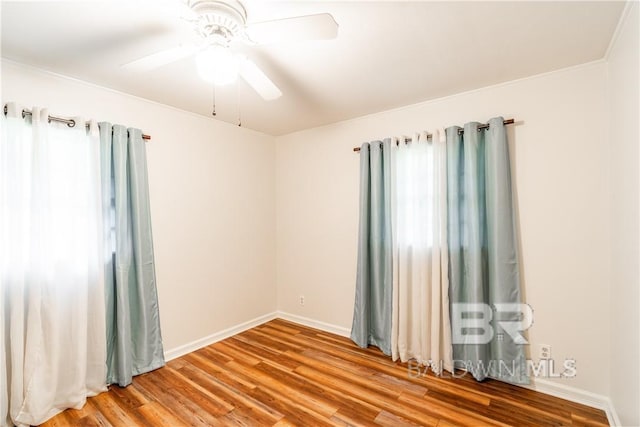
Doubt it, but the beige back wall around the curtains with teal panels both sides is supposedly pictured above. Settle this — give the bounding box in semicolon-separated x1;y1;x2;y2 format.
276;62;610;395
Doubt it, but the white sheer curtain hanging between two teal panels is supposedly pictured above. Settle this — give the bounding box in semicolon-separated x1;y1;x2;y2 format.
391;130;453;374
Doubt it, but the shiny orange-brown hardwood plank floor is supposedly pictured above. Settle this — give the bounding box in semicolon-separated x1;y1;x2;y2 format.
44;319;608;427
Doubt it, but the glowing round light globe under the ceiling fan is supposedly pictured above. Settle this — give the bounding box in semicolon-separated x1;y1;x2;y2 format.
196;45;238;86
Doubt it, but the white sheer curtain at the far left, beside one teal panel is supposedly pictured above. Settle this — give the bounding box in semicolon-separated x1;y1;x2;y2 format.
0;104;106;425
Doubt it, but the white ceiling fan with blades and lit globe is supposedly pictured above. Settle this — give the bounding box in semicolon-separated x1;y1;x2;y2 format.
122;0;338;100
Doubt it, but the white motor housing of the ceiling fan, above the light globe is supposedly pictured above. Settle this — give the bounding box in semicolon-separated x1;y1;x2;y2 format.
188;0;247;46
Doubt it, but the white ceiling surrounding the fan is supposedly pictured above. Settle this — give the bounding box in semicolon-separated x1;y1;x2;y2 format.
1;0;624;135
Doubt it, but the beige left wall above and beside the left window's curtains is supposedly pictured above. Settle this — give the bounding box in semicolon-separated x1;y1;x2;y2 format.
2;61;276;350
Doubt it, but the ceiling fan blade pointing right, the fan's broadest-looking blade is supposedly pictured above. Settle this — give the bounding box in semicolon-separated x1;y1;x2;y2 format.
246;13;338;44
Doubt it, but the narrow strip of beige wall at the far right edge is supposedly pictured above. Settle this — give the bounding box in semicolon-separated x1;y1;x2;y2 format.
608;2;640;426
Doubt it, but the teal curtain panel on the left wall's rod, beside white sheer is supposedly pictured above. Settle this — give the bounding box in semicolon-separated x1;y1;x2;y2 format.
99;123;165;386
